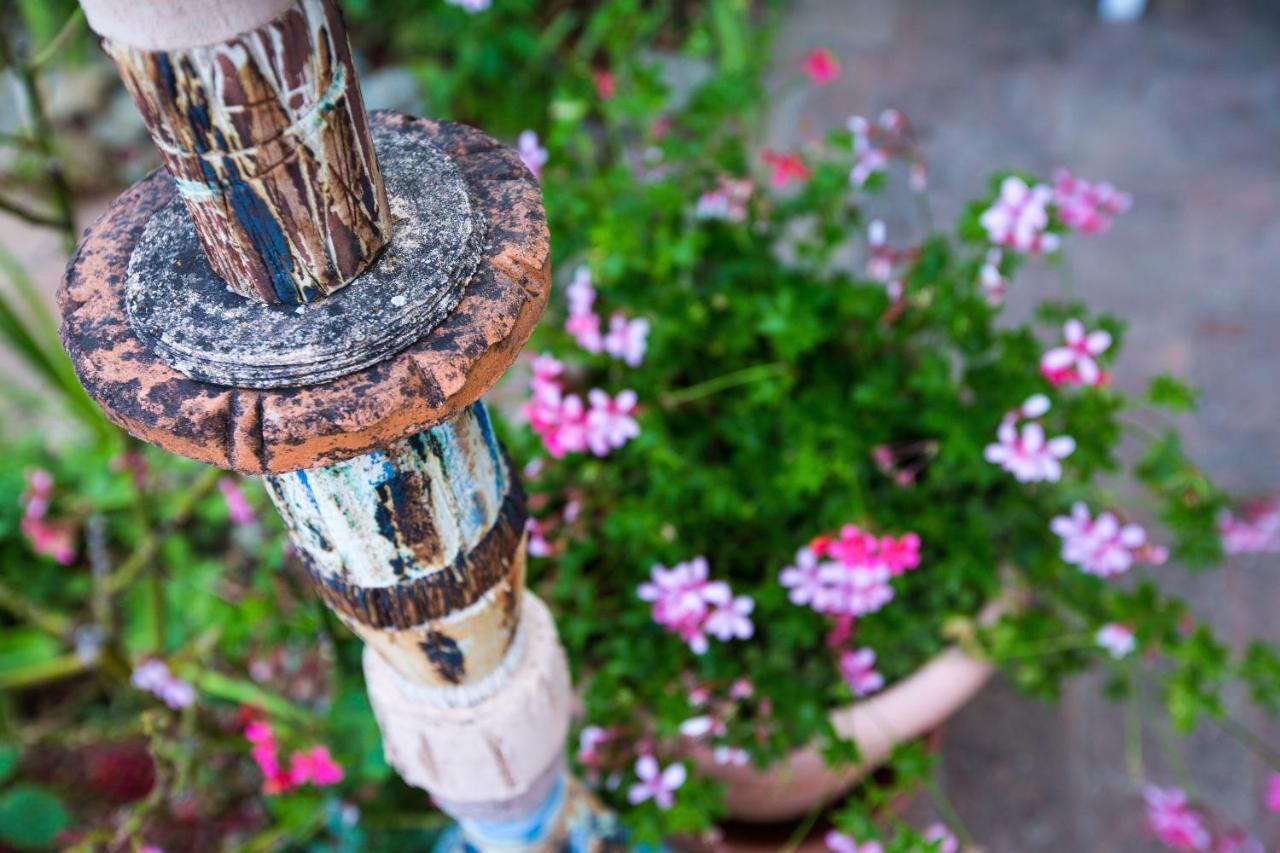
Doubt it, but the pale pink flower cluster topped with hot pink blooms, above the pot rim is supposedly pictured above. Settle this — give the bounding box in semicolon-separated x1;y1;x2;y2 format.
778;524;920;616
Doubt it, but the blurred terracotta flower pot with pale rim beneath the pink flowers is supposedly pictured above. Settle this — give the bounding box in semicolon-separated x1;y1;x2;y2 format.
692;648;993;822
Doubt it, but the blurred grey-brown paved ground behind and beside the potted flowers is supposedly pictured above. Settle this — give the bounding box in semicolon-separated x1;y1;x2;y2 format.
772;0;1280;853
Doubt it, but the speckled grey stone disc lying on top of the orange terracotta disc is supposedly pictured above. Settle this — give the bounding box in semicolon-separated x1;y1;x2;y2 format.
125;124;484;388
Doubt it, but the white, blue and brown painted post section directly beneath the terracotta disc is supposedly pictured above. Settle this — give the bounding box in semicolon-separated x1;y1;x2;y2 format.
264;402;526;686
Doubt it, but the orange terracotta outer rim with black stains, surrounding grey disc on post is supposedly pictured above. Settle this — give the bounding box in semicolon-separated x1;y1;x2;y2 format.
58;113;550;474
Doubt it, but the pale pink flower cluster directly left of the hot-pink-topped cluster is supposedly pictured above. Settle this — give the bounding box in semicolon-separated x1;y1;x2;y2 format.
636;557;755;654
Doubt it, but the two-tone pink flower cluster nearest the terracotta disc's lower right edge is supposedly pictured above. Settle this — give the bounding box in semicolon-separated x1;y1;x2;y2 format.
524;355;640;459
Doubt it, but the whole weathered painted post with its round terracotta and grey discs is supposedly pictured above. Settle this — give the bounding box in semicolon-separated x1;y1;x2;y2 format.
59;0;618;850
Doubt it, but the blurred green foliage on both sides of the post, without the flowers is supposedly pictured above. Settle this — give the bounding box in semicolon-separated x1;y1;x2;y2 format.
0;0;1280;850
